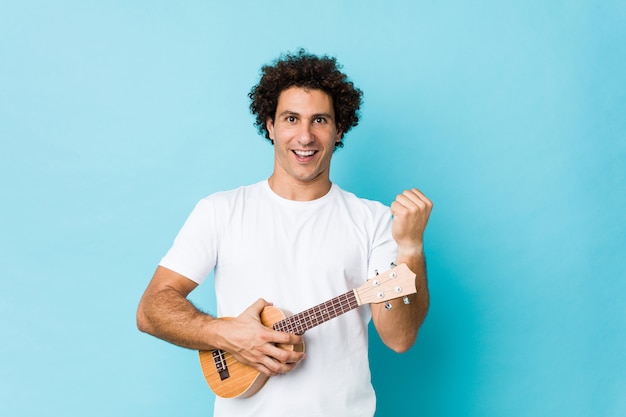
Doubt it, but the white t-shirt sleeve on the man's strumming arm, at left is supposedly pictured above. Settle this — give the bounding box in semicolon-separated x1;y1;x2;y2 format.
159;198;219;284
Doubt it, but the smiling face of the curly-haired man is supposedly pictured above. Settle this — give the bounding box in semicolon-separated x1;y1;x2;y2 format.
267;87;341;184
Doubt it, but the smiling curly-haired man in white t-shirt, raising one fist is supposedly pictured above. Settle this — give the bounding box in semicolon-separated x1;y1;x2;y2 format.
137;50;432;417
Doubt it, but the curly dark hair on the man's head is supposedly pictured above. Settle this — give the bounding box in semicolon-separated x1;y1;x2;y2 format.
248;49;363;148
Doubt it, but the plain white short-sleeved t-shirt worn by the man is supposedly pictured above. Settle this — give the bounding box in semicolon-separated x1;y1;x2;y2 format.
160;181;397;417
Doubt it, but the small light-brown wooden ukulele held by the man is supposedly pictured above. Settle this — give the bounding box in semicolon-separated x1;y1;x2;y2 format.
198;264;417;398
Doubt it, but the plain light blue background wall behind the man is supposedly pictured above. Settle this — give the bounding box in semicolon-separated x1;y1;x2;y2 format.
0;0;626;417
